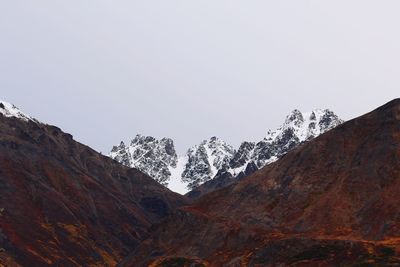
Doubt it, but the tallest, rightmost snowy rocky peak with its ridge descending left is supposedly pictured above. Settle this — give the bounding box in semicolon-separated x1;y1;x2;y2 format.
187;109;343;198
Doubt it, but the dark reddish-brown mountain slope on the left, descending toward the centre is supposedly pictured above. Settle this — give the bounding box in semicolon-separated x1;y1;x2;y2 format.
0;115;186;267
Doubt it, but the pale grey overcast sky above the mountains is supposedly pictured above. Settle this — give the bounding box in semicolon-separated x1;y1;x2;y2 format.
0;0;400;153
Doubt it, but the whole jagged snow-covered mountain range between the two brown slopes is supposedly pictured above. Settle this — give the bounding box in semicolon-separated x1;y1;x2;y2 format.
109;109;343;197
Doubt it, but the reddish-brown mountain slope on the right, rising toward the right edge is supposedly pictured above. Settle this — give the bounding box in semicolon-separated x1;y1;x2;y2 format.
123;99;400;266
